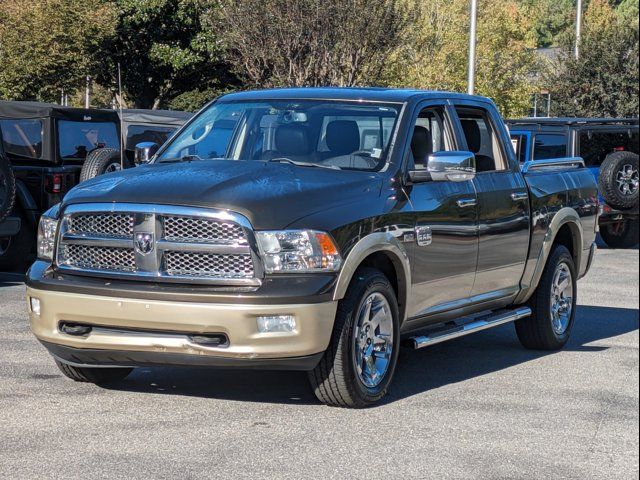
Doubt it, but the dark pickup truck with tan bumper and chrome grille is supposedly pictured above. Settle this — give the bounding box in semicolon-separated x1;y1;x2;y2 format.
27;88;599;407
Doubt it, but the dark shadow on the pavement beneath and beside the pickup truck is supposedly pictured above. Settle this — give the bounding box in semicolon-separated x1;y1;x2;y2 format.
102;306;638;404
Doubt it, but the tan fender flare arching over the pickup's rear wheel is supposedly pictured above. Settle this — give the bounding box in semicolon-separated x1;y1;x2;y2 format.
514;207;584;304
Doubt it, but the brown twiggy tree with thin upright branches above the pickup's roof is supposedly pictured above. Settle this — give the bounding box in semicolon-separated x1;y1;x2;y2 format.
215;0;401;87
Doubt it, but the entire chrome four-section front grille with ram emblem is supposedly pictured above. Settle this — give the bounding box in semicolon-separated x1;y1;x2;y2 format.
56;204;263;286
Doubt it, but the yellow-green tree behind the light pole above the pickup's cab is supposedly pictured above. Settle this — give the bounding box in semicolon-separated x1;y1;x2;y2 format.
385;0;537;116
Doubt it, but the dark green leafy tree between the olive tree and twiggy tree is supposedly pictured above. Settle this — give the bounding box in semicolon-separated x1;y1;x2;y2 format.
99;0;235;109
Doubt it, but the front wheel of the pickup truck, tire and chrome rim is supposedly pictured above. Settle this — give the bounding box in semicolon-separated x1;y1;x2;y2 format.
309;268;400;408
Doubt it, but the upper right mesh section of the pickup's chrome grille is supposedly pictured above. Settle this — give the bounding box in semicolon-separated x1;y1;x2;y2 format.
163;216;247;245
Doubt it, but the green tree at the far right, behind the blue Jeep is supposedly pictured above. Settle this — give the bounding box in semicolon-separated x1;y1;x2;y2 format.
545;0;640;117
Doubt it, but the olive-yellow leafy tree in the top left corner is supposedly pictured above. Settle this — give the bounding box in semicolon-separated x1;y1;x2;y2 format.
0;0;115;101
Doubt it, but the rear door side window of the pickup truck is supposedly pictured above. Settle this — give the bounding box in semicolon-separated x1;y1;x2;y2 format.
456;107;509;172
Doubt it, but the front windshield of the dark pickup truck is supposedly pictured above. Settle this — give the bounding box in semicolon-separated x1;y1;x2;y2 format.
157;100;400;170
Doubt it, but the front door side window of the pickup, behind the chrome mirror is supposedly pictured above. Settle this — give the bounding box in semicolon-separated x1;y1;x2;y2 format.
409;107;452;170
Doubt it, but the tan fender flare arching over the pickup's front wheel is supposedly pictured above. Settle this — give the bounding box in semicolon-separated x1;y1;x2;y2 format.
333;232;411;323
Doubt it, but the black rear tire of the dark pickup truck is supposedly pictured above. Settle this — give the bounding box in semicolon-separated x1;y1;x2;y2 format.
515;245;577;350
